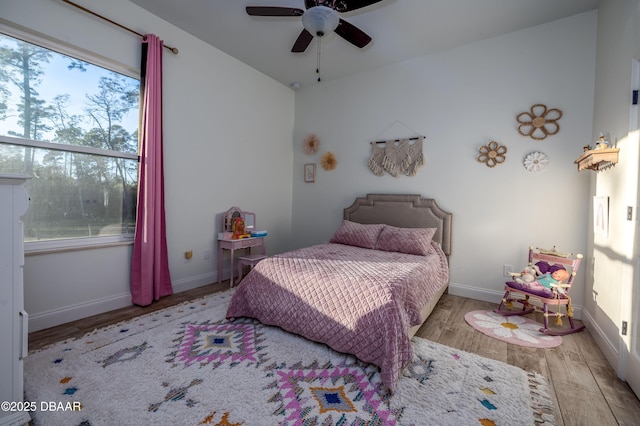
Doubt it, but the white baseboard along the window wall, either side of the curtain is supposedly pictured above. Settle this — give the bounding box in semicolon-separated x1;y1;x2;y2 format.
29;273;218;332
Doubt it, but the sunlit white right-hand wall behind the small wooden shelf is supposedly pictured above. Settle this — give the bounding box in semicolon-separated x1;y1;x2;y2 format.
585;0;640;378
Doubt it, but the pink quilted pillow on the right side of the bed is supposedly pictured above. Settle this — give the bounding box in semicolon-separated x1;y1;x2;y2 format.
376;225;436;256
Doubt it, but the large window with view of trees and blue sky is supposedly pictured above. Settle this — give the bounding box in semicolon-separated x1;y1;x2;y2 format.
0;33;140;248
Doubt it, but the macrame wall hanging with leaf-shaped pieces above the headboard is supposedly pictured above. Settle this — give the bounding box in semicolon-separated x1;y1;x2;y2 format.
369;136;424;177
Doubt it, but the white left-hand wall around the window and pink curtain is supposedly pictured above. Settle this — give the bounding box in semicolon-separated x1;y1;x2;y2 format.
1;0;295;331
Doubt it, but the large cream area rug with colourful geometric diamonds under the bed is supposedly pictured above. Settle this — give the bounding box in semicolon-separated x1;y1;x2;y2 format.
24;289;555;426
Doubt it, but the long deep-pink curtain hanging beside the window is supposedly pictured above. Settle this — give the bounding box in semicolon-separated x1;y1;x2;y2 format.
131;34;173;306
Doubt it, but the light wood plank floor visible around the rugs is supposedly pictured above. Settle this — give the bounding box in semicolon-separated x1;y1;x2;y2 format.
29;282;640;426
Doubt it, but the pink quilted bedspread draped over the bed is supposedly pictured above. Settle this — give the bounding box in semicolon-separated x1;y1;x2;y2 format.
227;243;449;391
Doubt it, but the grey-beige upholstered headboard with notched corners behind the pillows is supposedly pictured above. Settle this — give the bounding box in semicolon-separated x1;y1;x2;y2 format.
344;194;453;257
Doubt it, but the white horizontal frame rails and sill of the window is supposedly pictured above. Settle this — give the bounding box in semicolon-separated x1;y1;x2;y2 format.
0;22;140;255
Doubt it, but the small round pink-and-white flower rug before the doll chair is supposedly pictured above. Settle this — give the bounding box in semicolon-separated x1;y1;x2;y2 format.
464;311;562;348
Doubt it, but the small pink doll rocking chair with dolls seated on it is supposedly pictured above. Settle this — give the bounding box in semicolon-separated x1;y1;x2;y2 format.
494;247;584;336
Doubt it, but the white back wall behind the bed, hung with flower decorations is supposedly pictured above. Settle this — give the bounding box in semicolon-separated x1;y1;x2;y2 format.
293;11;597;308
